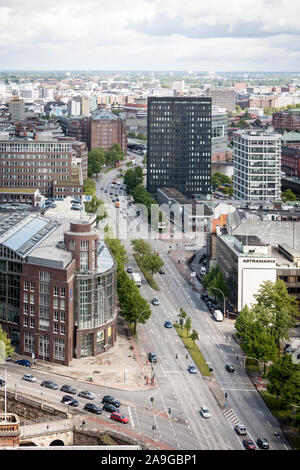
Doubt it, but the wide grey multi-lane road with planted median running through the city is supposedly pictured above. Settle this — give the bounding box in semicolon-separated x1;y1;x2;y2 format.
93;156;290;450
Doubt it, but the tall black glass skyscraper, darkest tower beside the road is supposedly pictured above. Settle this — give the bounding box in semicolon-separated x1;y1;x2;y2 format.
147;97;211;198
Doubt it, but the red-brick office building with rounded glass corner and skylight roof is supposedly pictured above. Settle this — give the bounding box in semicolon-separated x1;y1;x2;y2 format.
0;212;117;365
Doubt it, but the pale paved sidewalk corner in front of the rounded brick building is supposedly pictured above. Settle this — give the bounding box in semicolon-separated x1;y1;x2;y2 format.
32;317;157;391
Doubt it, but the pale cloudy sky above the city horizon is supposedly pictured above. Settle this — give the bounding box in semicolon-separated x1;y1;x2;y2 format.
0;0;300;72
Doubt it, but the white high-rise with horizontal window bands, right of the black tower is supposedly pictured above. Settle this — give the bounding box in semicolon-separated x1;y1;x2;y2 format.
233;131;281;202
